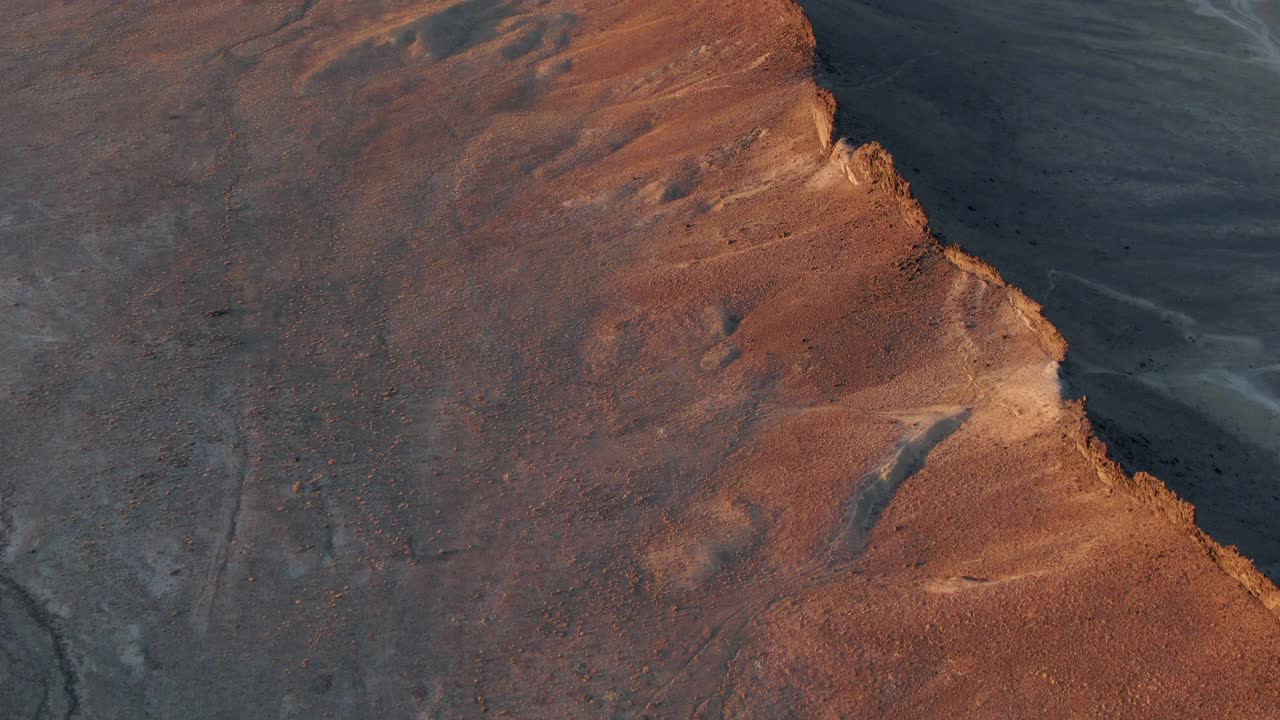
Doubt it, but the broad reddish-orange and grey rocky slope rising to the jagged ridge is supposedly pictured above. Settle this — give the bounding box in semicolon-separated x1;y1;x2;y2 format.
0;0;1280;719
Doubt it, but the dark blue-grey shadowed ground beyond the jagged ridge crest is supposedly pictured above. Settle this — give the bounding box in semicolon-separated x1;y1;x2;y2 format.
801;0;1280;577
